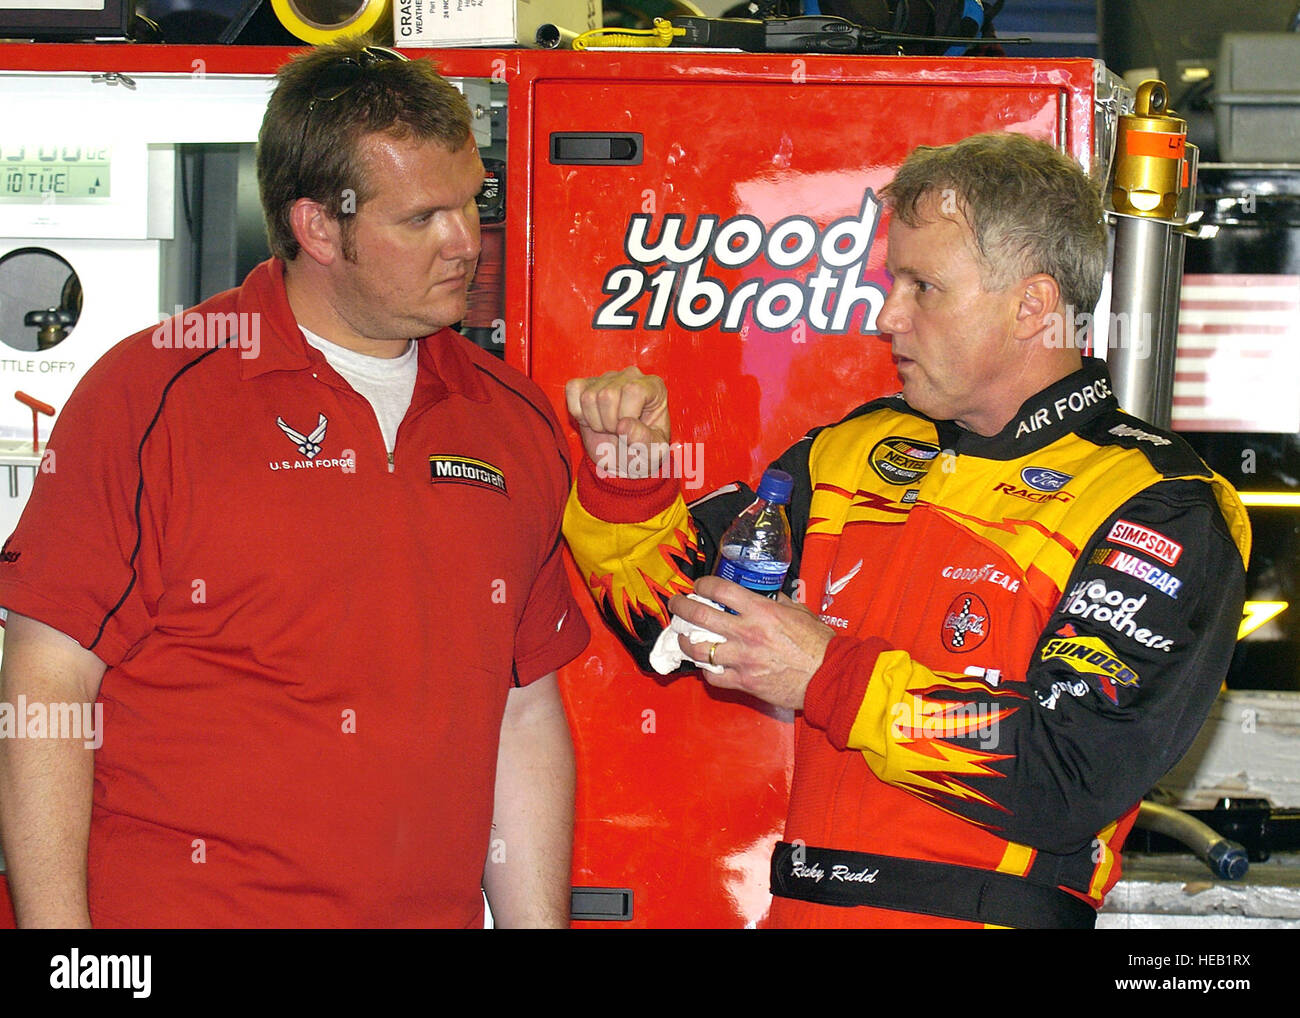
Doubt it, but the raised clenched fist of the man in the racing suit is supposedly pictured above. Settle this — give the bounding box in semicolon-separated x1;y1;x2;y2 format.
564;367;671;477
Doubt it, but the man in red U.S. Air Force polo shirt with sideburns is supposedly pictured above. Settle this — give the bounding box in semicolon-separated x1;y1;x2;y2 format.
0;44;588;927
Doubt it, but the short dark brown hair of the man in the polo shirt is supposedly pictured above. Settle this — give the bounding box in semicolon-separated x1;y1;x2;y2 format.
257;39;469;261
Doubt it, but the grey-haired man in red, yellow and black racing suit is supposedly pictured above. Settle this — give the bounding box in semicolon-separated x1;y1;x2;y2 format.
566;135;1249;927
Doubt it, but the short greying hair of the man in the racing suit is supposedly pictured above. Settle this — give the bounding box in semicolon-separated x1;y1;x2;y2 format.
881;133;1106;312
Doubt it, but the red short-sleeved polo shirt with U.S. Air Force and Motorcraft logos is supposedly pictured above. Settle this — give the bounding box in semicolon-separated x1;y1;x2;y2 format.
0;261;588;927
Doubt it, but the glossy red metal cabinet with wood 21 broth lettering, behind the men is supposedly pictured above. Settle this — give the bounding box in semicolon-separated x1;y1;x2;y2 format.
511;53;1096;927
